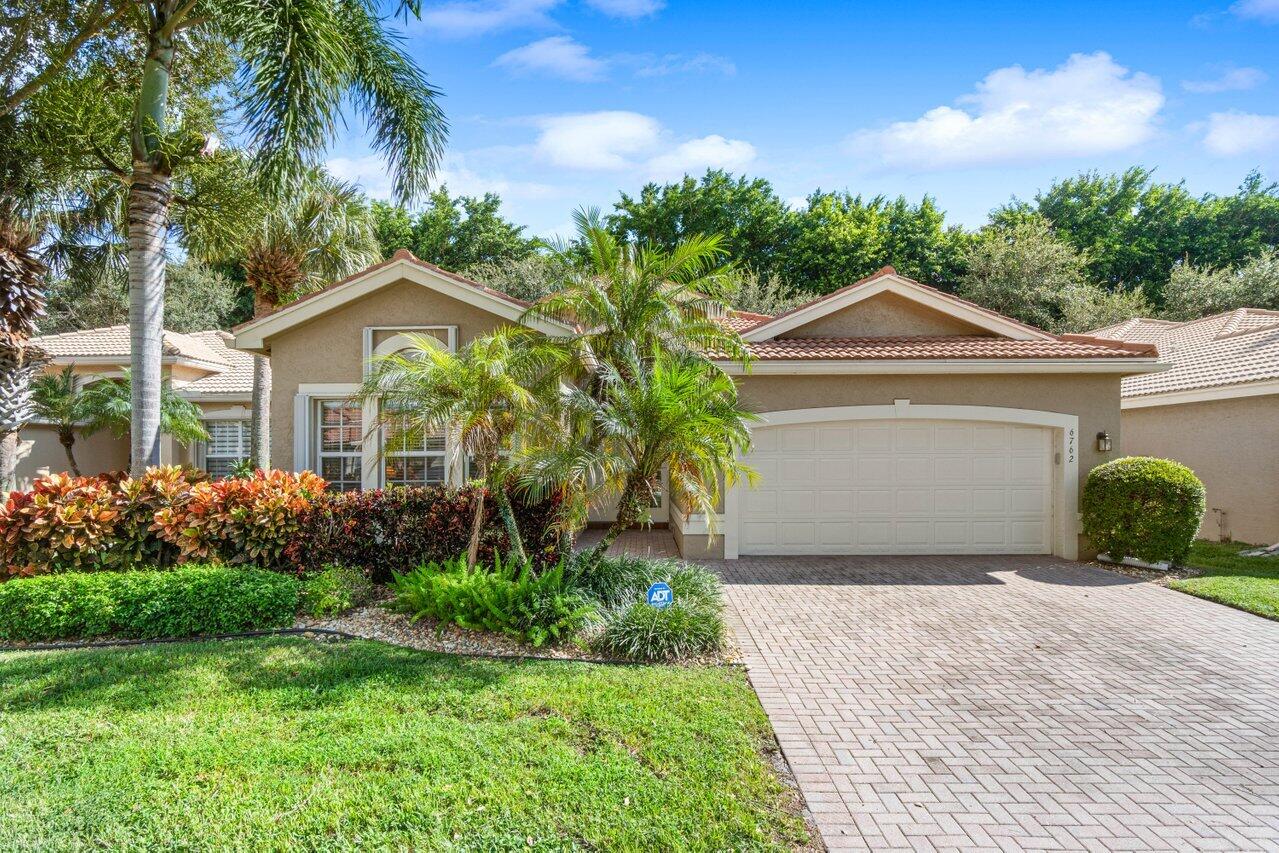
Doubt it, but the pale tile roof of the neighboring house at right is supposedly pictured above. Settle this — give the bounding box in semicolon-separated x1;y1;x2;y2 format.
1092;308;1279;396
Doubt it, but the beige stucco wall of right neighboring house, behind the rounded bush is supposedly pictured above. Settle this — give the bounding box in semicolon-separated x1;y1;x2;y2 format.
1123;396;1279;545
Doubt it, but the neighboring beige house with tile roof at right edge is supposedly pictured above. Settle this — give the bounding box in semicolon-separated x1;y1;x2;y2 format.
1090;308;1279;544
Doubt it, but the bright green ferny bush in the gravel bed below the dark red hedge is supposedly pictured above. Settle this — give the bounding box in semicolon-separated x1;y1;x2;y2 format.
391;556;595;647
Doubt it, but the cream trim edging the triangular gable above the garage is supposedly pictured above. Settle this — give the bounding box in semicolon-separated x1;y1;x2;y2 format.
742;266;1055;343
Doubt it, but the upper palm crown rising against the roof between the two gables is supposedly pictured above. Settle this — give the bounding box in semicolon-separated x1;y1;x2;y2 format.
527;210;747;390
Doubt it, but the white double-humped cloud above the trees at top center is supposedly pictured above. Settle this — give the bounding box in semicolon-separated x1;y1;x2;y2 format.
535;110;756;178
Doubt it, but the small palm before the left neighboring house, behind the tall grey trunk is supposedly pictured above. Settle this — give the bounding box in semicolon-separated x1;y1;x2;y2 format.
32;364;208;477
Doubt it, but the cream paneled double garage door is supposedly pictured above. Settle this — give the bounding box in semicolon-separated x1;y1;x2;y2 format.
738;421;1053;554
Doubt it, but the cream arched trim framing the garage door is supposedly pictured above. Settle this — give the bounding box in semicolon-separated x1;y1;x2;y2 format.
723;400;1079;560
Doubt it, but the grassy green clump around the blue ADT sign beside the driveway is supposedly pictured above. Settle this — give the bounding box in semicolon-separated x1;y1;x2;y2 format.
577;556;726;661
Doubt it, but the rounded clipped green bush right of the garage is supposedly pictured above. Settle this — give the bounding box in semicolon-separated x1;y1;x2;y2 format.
1083;457;1204;563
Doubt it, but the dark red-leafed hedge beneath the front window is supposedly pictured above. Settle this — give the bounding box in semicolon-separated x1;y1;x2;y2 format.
286;486;559;582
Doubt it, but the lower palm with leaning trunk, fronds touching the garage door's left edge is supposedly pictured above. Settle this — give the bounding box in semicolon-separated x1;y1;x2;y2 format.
522;350;756;559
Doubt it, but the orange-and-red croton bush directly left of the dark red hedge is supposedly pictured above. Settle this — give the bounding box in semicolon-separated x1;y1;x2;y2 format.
155;471;325;569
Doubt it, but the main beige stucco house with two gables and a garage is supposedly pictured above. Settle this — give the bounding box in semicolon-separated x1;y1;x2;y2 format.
235;251;1160;558
